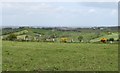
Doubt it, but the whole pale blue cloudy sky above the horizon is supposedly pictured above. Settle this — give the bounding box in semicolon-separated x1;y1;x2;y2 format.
0;2;118;27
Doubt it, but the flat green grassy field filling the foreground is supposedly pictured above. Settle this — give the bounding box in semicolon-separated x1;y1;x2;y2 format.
2;41;118;71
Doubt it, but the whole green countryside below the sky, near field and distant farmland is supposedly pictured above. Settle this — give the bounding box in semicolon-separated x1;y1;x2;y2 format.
2;27;120;71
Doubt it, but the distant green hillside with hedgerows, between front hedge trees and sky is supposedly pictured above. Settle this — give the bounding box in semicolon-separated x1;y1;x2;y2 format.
2;27;119;42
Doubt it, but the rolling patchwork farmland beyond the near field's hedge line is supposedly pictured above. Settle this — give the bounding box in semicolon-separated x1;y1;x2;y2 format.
2;27;118;42
